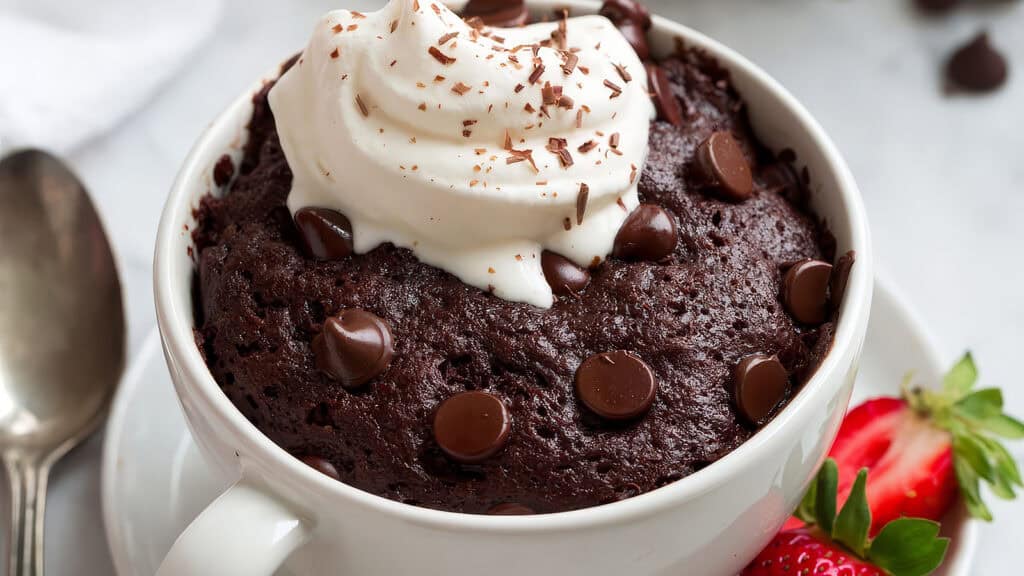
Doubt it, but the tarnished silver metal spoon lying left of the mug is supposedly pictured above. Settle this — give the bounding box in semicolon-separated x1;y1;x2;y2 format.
0;150;125;576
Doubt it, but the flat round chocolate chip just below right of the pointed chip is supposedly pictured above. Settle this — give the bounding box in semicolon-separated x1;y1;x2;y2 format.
434;390;512;463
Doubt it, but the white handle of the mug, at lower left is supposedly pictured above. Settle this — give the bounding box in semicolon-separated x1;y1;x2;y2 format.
156;479;310;576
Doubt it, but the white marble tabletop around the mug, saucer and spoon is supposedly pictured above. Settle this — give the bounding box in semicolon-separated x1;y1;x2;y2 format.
9;0;1024;575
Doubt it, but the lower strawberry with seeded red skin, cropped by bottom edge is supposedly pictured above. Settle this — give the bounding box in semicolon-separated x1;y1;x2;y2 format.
740;458;949;576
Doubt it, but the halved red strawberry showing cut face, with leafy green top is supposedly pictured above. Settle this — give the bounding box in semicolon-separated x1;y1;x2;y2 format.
798;354;1024;535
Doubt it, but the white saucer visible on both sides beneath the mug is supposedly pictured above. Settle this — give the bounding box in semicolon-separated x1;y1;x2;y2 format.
102;276;977;576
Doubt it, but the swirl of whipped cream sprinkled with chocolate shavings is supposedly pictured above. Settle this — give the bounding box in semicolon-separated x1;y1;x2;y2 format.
269;0;654;307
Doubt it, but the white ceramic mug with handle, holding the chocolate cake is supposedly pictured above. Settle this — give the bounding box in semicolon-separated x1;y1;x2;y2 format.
155;0;872;576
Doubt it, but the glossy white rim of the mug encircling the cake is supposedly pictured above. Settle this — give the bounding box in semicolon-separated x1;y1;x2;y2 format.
154;0;872;533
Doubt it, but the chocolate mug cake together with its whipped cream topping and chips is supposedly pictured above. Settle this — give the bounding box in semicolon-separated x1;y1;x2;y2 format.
194;0;853;513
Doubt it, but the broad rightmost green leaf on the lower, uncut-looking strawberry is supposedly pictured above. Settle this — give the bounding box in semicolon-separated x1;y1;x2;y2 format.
867;518;949;576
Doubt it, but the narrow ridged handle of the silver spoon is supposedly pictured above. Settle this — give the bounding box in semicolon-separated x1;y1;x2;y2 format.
3;453;50;576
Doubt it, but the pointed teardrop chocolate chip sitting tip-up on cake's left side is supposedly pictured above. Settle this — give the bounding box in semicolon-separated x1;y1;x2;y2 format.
313;308;394;388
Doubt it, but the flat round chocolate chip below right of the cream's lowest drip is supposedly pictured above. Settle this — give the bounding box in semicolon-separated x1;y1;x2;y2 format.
575;351;657;420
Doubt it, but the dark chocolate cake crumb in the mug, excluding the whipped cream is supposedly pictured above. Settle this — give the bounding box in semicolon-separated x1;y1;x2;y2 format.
195;0;835;513
